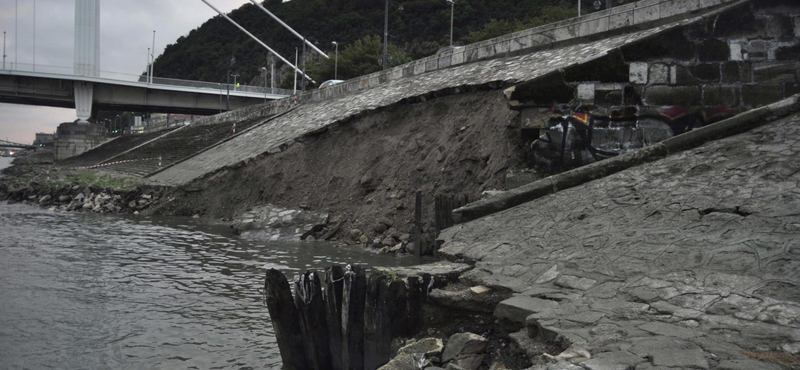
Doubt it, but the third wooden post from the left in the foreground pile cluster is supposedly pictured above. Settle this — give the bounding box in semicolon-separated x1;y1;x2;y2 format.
323;266;344;370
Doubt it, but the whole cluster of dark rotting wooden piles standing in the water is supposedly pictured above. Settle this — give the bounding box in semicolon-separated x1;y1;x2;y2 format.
265;265;444;370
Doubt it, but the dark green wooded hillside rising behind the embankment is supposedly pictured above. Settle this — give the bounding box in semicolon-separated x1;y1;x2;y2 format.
155;0;632;87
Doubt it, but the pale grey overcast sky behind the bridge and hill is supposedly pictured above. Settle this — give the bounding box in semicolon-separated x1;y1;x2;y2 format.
0;0;253;143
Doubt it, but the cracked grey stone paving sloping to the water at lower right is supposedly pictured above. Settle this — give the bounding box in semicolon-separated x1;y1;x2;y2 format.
440;114;800;370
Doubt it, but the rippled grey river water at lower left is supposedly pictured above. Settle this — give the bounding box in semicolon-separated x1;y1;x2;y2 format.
0;158;418;369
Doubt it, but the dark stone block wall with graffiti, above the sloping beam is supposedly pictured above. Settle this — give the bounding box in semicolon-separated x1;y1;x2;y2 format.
506;0;800;173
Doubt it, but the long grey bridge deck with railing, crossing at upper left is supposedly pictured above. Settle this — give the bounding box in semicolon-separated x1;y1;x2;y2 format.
0;64;292;116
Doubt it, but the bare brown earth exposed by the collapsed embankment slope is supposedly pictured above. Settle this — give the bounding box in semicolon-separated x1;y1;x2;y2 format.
157;90;522;251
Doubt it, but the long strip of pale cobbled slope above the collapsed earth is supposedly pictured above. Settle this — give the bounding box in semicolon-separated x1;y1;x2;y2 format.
152;17;701;185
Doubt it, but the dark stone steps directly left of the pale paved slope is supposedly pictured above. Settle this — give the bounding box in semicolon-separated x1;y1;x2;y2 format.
104;118;263;177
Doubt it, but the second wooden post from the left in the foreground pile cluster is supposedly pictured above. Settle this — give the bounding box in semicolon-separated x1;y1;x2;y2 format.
294;271;331;370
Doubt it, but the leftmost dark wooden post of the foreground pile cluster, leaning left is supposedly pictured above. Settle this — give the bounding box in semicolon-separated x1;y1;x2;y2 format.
264;269;309;370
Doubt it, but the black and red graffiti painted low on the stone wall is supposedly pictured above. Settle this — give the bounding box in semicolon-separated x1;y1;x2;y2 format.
529;105;731;173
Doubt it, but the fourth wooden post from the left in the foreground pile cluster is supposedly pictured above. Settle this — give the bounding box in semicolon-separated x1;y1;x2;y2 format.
342;265;367;370
